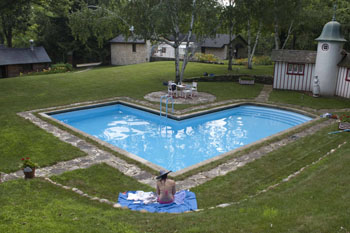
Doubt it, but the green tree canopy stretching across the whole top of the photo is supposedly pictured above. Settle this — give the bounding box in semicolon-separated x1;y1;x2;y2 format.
0;0;350;67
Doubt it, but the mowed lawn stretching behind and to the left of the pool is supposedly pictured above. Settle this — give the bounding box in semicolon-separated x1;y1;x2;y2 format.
0;62;264;173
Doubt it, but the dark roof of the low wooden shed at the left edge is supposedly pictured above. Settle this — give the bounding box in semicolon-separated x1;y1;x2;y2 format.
0;47;51;65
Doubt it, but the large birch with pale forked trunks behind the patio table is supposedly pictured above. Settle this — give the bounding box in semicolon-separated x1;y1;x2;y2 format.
69;0;219;82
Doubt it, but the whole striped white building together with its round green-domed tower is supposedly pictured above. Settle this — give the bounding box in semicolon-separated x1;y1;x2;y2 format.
271;19;350;98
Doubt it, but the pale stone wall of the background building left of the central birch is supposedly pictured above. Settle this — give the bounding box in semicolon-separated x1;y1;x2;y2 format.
111;41;151;65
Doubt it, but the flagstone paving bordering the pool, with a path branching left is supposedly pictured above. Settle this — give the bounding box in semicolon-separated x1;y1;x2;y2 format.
1;87;340;189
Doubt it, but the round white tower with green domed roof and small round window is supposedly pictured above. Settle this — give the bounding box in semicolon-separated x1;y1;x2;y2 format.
315;16;346;96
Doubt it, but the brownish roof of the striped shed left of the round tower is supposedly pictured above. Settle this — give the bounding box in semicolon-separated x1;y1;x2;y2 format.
271;49;317;63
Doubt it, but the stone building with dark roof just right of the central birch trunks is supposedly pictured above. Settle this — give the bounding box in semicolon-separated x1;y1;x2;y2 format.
199;34;248;60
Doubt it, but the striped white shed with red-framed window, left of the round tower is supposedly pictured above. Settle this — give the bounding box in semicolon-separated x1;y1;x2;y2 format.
271;50;317;91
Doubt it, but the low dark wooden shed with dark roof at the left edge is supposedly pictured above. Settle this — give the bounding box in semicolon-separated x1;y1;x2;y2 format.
0;46;51;78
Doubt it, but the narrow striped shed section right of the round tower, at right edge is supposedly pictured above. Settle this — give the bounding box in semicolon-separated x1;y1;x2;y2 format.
335;53;350;98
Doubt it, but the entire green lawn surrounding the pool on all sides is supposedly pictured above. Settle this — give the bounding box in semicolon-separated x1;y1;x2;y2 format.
0;62;350;232
